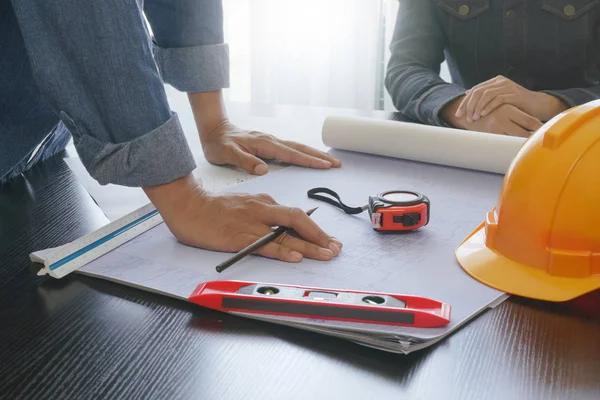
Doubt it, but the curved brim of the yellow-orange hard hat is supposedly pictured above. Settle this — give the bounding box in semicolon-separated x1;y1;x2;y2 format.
456;223;600;302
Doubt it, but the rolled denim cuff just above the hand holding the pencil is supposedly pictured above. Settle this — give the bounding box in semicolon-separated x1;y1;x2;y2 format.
71;113;196;187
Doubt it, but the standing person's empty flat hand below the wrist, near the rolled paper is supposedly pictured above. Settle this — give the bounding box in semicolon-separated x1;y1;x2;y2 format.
200;121;341;175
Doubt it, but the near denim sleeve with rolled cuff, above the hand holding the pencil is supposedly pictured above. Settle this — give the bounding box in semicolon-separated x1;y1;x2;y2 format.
13;0;196;187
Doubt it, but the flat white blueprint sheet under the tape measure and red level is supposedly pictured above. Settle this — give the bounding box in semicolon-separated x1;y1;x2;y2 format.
71;150;506;353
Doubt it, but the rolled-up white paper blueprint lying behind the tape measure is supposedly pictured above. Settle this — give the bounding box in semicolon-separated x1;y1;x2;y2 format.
322;116;526;174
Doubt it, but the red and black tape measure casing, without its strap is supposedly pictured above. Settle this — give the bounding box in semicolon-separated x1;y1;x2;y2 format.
369;190;430;231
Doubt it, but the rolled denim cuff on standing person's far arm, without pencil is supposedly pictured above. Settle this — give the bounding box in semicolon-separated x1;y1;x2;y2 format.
153;43;229;92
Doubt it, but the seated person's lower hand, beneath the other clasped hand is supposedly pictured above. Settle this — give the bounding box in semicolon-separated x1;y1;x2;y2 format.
442;98;542;137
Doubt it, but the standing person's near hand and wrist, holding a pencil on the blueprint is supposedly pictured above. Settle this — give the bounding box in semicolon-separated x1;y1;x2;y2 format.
144;175;342;262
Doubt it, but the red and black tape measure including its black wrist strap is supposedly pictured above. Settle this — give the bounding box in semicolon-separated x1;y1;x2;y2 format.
308;187;430;231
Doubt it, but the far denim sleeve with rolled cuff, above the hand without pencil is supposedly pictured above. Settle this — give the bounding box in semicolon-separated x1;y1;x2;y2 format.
144;0;230;92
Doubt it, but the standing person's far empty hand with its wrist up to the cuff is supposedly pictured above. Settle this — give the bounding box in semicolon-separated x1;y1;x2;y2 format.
188;91;341;175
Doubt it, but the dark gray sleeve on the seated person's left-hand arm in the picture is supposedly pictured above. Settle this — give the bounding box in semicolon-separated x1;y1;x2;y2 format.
385;0;465;126
